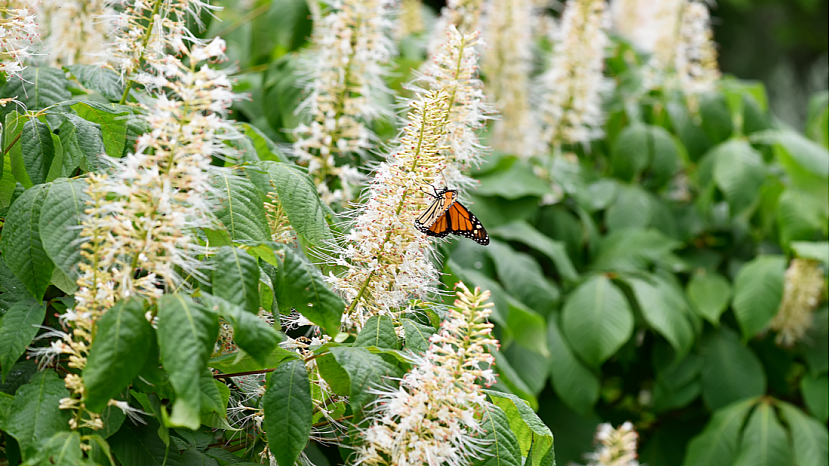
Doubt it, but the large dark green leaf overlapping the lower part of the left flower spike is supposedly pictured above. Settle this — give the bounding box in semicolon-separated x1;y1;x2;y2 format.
83;299;153;413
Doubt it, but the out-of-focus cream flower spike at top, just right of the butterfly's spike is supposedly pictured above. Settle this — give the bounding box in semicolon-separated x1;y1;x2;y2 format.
483;0;537;157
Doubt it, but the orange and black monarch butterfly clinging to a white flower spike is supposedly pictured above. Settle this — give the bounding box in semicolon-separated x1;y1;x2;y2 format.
415;188;490;246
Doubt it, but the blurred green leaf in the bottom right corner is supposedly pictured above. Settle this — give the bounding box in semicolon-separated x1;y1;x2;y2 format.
780;400;828;466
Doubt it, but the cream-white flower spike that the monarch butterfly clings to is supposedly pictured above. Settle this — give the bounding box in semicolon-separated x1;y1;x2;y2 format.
328;91;449;330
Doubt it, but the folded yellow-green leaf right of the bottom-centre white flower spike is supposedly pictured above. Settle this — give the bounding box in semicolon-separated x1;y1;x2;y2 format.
484;390;553;466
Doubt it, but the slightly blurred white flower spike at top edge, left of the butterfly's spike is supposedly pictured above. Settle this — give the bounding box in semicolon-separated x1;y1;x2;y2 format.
294;0;395;204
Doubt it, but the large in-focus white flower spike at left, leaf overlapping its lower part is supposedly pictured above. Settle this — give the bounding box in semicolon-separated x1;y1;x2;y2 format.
56;39;236;428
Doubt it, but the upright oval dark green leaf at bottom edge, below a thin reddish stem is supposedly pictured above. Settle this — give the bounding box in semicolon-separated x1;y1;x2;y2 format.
262;360;314;466
